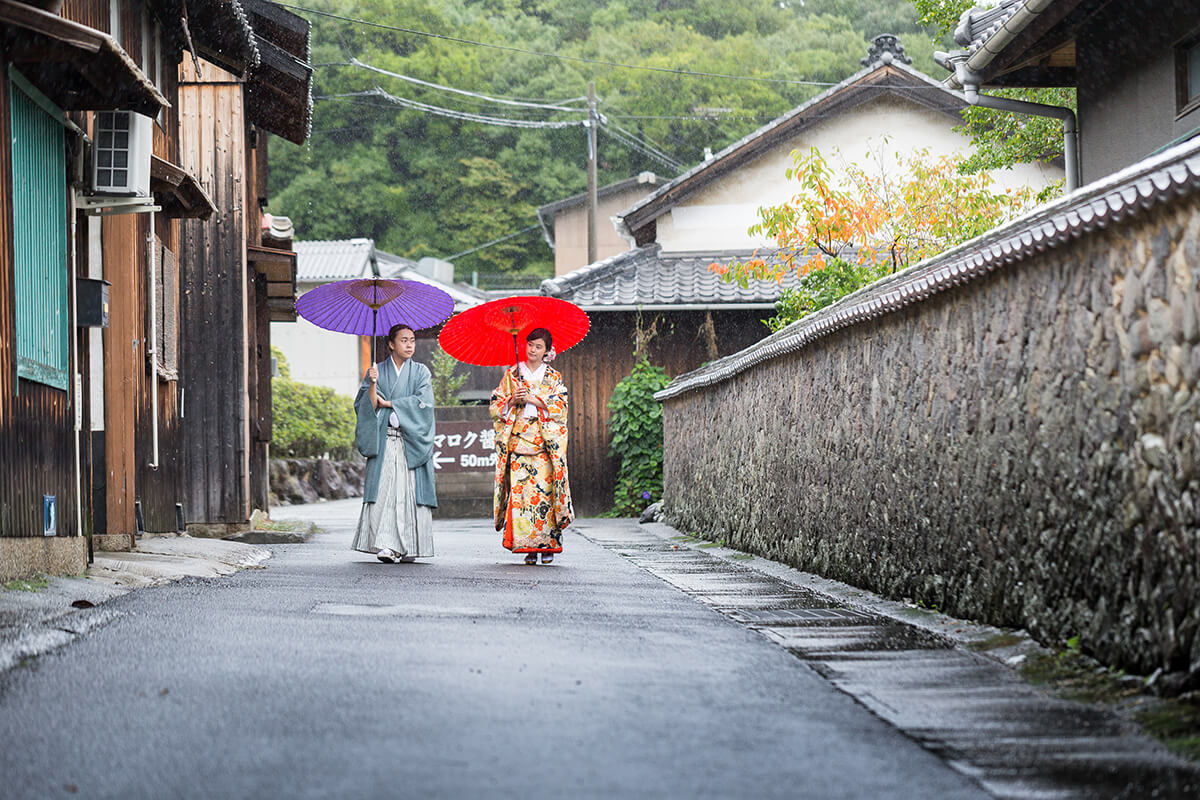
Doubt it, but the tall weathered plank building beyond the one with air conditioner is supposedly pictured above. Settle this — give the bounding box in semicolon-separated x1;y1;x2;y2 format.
179;0;312;536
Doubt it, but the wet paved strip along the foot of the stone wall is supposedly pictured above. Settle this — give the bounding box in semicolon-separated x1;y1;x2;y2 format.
580;528;1200;800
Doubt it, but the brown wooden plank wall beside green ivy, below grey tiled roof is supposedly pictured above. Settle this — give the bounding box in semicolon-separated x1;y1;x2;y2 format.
554;311;770;516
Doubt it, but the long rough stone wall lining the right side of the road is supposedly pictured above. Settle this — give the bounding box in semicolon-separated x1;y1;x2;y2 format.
659;145;1200;685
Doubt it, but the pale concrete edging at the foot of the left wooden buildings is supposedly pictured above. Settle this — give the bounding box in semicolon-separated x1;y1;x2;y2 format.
0;536;271;675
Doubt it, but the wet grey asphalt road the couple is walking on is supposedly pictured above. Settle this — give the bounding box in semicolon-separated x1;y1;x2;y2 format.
0;500;986;798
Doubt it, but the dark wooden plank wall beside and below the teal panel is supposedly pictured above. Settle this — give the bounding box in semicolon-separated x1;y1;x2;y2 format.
0;62;79;536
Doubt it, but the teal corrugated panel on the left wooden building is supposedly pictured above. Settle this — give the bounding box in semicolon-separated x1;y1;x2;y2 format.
10;82;71;390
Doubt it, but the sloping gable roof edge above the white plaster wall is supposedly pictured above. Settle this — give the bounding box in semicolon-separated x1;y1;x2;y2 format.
616;62;967;240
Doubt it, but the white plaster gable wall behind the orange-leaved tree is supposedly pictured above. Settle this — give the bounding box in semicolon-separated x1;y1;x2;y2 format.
658;97;1063;252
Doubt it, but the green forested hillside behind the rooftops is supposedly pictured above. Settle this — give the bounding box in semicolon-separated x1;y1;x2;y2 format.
269;0;942;285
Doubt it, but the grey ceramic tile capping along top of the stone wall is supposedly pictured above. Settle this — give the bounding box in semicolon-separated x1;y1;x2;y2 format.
654;140;1200;402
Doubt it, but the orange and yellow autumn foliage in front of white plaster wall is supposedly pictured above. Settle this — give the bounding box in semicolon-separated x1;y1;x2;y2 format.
709;148;1034;287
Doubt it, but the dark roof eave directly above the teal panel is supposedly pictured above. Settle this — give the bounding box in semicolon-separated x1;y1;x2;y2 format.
0;0;170;116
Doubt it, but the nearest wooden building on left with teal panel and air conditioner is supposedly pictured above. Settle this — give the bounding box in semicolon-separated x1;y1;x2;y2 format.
0;0;310;579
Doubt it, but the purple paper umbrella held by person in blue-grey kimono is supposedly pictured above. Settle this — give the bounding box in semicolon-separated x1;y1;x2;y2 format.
296;278;454;336
